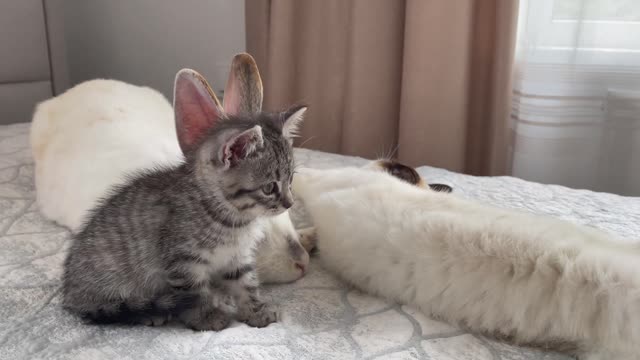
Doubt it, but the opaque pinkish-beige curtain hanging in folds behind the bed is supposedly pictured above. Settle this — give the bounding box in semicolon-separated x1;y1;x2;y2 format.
246;0;517;175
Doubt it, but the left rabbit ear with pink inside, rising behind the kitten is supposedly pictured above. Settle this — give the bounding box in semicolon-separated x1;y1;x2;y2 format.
173;69;222;154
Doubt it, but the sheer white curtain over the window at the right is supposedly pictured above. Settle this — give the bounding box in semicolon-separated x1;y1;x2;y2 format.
511;0;640;196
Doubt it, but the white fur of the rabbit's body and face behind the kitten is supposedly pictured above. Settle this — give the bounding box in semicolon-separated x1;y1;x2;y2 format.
31;79;309;282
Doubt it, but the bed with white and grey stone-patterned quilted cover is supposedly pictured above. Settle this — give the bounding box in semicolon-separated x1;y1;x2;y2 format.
0;124;640;360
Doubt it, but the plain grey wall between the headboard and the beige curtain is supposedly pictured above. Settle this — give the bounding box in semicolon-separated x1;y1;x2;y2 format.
64;0;245;99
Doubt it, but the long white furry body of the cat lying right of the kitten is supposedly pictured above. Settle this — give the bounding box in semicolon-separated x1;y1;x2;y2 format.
293;168;640;360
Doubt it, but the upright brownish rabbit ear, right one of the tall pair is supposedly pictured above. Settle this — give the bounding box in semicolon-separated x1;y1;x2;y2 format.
222;53;262;114
